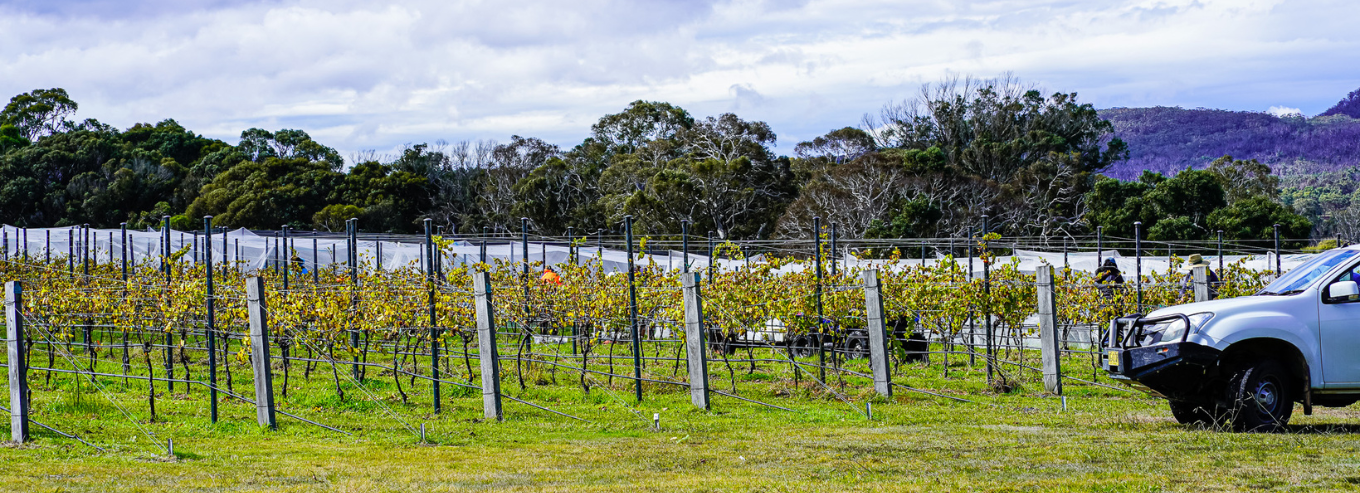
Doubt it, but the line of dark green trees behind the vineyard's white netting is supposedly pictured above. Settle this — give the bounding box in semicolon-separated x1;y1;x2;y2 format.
0;78;1311;240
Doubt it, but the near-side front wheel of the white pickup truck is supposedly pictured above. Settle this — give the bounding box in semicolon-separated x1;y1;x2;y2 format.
1228;360;1293;432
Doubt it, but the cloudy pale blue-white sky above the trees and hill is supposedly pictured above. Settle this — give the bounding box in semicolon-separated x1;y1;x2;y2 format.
0;0;1360;157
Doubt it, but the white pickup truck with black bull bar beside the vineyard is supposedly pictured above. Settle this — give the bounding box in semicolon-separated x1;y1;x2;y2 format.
1104;245;1360;432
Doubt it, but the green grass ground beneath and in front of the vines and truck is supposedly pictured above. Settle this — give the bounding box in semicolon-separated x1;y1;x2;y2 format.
0;343;1360;492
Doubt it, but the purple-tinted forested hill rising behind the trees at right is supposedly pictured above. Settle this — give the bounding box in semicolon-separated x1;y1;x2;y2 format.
1099;90;1360;180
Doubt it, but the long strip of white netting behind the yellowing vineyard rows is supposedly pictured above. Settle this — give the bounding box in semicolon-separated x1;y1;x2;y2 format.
0;225;1312;276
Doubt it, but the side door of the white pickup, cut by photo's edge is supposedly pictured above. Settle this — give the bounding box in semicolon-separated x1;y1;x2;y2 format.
1318;266;1360;387
